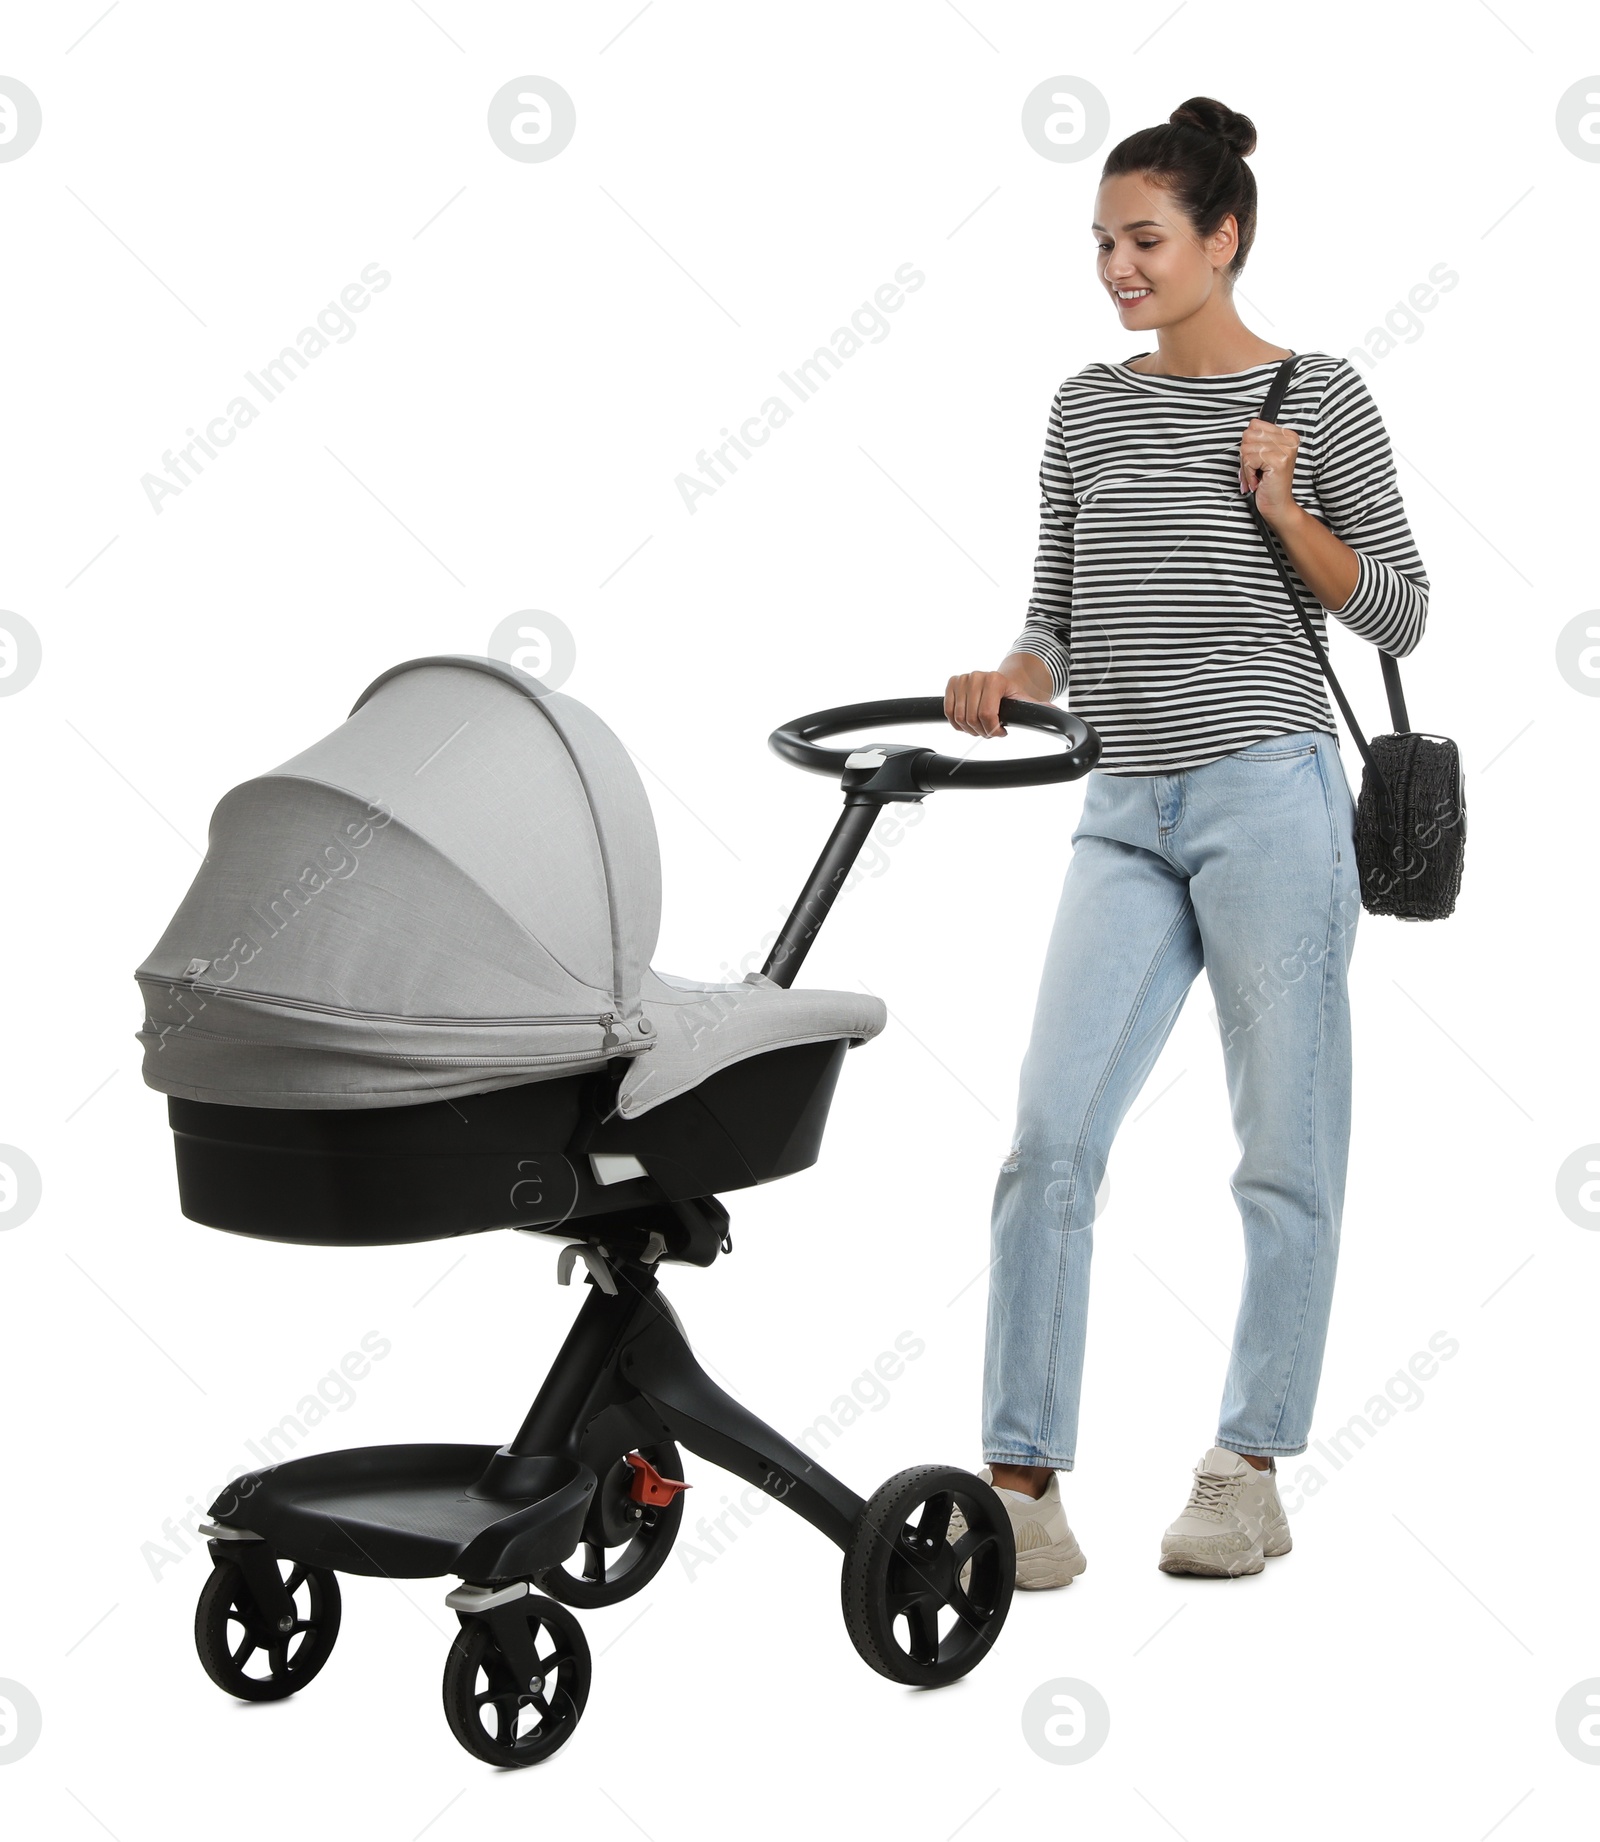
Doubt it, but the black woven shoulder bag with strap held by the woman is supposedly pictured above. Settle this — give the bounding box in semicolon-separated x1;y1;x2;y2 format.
1245;354;1467;921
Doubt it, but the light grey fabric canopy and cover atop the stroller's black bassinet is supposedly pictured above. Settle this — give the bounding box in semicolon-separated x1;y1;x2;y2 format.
136;658;886;1116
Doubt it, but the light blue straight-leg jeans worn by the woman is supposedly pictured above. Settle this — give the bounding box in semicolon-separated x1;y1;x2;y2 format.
983;731;1361;1470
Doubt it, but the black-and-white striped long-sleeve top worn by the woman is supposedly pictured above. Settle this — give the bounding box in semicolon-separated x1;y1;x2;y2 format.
1013;352;1429;774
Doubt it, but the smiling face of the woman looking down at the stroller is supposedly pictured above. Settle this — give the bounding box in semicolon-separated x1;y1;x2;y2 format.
1094;173;1239;332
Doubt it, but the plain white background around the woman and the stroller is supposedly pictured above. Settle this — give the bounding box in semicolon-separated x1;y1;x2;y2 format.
0;0;1600;1842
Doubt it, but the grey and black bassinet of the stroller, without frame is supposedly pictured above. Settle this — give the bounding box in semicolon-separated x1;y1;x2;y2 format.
138;659;886;1264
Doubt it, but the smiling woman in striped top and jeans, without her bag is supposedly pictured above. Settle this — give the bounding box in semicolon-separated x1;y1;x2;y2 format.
945;96;1429;1586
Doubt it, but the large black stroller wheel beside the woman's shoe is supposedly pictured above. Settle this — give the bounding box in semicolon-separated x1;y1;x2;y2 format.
840;1464;1016;1689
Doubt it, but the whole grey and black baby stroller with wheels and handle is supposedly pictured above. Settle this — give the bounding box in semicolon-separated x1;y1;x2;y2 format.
136;658;1099;1766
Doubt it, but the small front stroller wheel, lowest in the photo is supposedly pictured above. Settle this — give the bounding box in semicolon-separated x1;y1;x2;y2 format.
444;1593;591;1766
